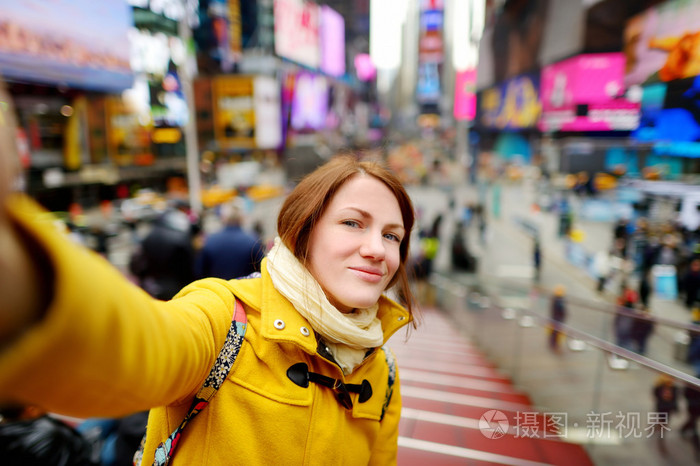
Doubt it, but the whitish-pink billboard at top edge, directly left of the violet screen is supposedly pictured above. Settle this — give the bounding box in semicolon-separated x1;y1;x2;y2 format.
273;0;321;68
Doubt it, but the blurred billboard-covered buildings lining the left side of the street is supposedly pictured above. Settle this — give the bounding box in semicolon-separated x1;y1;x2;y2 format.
0;0;381;211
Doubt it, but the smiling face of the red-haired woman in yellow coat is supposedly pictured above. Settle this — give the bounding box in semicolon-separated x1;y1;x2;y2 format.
308;175;406;312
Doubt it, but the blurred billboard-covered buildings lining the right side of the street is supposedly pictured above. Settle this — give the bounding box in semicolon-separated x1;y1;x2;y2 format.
471;0;700;180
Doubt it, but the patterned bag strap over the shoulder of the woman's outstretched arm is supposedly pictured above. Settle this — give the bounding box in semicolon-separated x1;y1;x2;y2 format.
134;299;248;466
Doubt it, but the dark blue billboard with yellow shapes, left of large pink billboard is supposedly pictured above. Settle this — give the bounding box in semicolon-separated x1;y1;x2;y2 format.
476;74;542;129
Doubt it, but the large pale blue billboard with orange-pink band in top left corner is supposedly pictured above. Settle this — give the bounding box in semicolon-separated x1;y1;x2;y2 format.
0;0;133;92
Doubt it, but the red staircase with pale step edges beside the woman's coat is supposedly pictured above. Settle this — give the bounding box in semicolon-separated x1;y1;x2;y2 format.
390;309;593;466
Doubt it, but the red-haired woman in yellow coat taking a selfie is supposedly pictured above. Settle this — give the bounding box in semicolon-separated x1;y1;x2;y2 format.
0;156;414;465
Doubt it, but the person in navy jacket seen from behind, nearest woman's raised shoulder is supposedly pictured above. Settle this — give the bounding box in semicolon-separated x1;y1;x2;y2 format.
195;202;265;280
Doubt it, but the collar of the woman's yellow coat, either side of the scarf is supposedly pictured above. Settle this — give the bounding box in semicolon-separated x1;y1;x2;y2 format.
230;258;411;354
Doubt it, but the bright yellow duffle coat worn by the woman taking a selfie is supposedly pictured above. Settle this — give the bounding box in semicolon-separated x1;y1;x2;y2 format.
0;199;410;466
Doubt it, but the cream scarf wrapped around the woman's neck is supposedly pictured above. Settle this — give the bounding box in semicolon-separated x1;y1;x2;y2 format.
267;237;384;374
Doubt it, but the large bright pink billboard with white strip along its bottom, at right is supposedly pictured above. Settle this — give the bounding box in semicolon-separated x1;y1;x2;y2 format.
539;52;639;131
